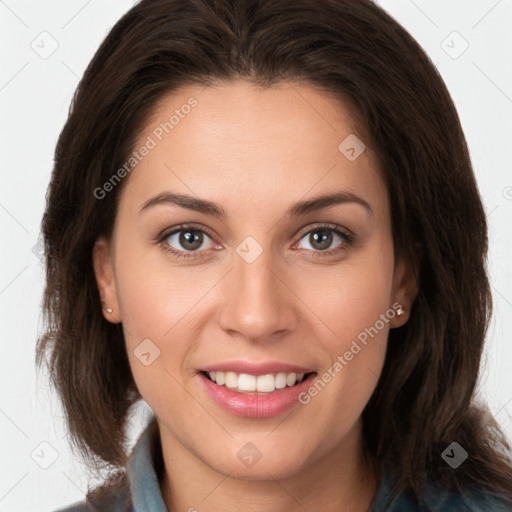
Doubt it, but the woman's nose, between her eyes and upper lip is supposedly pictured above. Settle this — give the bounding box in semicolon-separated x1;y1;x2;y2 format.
219;246;300;343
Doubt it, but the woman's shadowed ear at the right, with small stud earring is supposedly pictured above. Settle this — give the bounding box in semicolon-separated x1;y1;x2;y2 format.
390;252;419;328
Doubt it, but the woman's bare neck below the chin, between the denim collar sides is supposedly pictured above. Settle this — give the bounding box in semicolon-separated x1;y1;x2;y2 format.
160;420;378;512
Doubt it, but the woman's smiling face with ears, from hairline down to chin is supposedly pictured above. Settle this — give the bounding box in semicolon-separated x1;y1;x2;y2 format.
94;81;410;479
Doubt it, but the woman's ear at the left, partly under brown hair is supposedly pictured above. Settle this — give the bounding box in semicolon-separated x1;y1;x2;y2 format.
92;237;121;324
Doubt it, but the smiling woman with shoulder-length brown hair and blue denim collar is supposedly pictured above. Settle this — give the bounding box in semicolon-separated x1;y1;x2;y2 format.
38;0;512;512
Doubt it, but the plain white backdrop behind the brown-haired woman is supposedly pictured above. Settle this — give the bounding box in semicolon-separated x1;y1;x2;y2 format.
0;0;512;512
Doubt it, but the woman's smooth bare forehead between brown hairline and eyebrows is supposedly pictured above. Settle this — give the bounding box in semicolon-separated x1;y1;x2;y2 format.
117;81;387;221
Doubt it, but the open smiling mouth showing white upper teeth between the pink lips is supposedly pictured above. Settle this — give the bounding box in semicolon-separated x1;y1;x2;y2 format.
201;371;315;395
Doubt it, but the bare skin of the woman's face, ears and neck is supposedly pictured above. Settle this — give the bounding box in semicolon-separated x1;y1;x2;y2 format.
93;81;416;512
